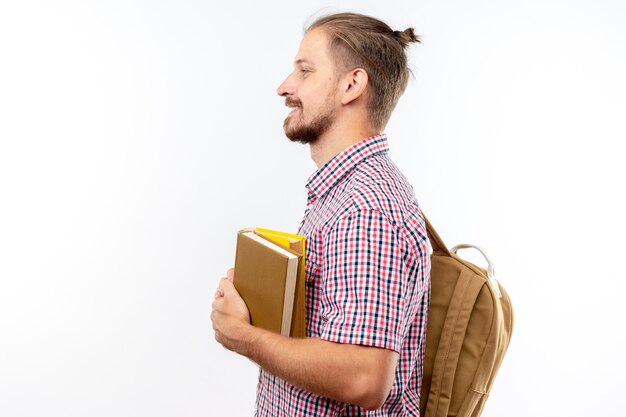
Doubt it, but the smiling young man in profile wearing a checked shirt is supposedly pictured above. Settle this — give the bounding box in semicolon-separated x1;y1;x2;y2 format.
211;13;430;417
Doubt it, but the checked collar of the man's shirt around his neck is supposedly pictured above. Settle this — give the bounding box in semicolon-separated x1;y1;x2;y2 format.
306;133;389;199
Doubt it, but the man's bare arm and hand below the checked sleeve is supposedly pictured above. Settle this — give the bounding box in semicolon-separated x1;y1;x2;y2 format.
211;269;398;410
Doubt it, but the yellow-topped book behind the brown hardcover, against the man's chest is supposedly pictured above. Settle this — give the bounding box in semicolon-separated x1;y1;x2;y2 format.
254;227;306;337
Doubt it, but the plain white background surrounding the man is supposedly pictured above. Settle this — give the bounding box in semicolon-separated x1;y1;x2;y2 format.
0;0;626;417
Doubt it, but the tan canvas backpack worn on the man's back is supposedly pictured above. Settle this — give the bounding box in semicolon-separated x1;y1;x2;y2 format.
420;214;513;417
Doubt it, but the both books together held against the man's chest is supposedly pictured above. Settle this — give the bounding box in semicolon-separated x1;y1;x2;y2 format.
234;228;306;337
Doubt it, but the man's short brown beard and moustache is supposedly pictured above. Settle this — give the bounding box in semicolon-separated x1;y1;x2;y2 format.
283;97;335;144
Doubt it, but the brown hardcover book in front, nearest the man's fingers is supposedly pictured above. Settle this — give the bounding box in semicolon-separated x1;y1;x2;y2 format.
233;229;302;336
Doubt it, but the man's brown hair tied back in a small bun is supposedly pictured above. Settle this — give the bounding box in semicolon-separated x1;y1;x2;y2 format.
305;13;420;130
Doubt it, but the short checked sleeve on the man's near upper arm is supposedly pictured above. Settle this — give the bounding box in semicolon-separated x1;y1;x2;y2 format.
320;210;412;351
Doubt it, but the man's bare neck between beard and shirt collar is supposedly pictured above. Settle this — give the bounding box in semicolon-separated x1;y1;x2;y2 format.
310;125;379;169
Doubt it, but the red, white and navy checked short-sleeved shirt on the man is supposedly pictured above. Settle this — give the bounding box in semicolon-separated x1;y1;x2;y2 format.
255;135;430;417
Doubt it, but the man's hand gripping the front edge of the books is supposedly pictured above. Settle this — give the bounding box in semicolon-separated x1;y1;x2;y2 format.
211;268;251;354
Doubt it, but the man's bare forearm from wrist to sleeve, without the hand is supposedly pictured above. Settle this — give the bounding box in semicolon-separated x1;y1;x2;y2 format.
238;326;398;409
